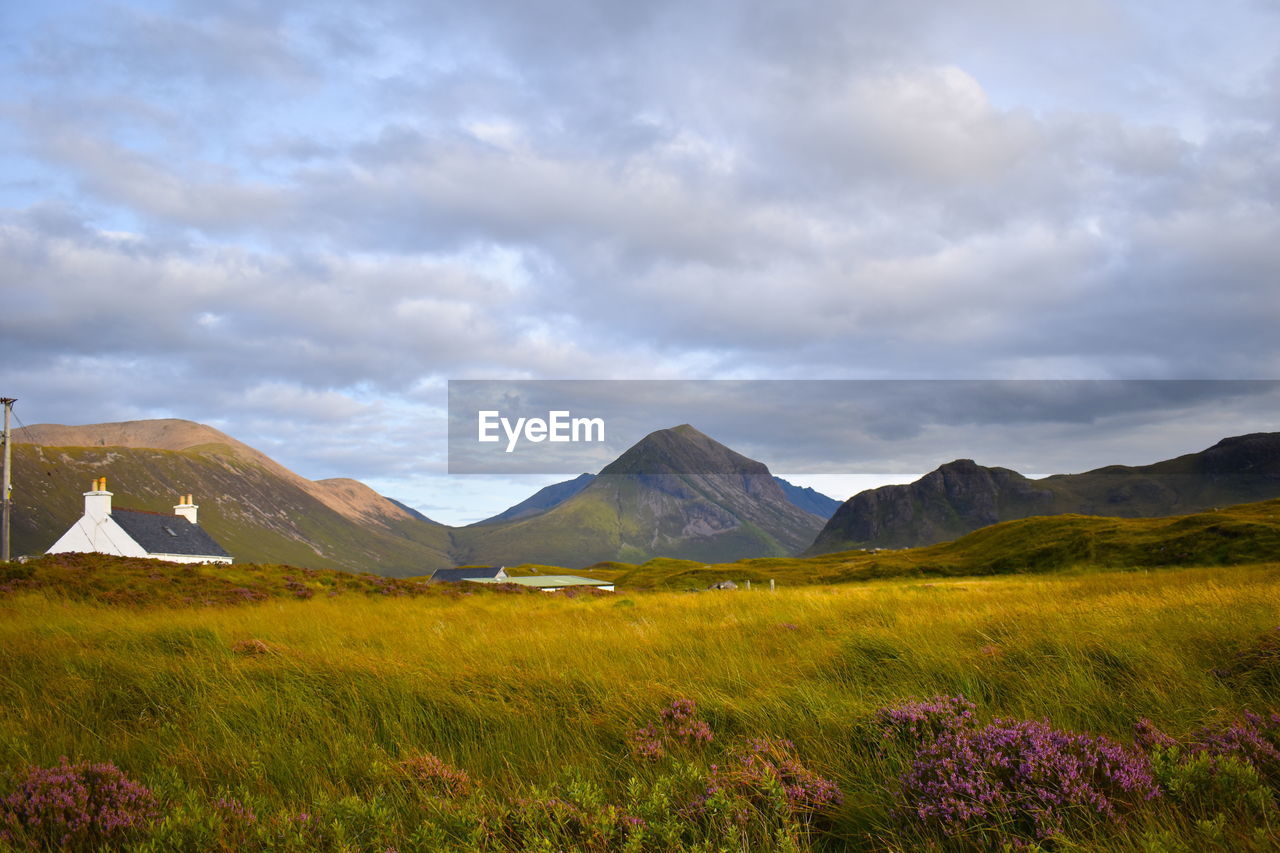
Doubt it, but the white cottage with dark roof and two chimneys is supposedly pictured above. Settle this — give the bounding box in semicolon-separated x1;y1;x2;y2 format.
46;476;232;562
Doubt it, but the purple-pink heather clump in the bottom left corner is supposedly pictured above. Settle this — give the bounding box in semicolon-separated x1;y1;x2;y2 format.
0;756;157;849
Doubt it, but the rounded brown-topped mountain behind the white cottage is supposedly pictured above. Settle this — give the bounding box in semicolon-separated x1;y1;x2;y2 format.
5;419;453;576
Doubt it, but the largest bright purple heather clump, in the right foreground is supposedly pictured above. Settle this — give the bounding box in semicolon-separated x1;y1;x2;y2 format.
895;720;1160;840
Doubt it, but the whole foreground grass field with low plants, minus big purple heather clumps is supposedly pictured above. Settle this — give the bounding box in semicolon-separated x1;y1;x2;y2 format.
0;550;1280;852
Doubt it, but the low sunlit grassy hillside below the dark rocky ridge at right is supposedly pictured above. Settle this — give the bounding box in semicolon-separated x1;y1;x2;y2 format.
611;500;1280;589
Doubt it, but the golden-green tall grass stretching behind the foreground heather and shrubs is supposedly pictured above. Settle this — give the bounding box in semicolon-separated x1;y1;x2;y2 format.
0;564;1280;850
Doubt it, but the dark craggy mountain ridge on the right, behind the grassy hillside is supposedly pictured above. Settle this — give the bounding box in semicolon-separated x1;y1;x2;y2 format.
805;433;1280;555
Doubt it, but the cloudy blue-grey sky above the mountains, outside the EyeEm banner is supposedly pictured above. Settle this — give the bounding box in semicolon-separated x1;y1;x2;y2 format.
0;0;1280;523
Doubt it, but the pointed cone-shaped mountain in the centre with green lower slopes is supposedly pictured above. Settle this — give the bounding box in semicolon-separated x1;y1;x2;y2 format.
454;424;822;569
